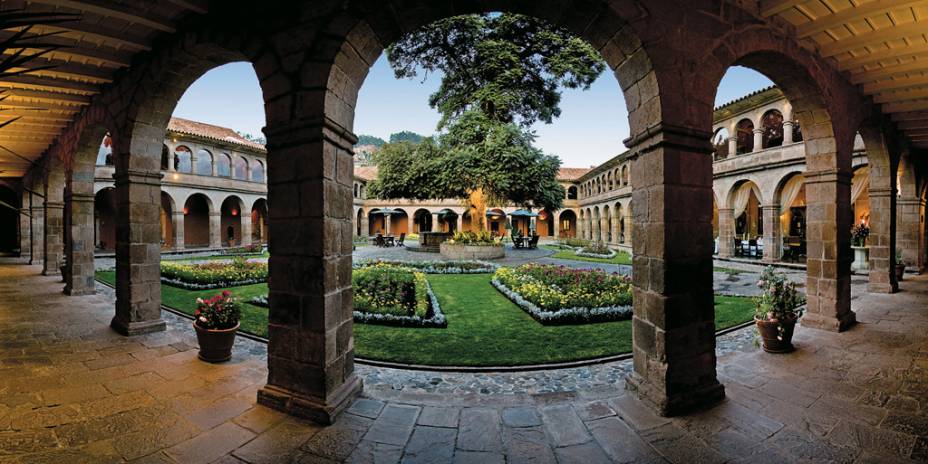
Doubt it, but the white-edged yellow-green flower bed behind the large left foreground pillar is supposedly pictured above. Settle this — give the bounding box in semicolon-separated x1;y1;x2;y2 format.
254;262;448;327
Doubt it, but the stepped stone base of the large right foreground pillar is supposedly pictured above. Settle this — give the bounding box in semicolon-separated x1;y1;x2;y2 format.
625;372;725;417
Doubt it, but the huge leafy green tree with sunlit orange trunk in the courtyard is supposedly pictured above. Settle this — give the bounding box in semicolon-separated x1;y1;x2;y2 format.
370;14;605;228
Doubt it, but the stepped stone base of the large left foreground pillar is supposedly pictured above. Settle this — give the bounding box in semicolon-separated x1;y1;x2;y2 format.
258;375;362;425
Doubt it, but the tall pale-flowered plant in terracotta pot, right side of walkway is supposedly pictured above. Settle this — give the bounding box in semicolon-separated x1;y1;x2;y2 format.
754;266;806;353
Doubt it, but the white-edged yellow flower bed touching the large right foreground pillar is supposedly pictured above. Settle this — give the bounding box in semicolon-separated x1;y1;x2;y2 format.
492;264;632;324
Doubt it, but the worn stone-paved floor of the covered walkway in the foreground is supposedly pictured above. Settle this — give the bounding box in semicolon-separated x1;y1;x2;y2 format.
0;265;928;464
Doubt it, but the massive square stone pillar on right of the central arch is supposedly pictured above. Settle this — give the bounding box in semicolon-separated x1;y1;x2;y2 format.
626;125;725;415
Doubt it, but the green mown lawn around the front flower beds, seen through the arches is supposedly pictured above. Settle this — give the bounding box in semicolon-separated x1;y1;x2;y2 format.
97;271;753;366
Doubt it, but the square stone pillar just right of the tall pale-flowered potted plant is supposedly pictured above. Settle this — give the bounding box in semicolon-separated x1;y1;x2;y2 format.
801;169;856;331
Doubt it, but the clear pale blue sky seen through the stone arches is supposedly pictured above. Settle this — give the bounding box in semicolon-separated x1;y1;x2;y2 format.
174;56;772;167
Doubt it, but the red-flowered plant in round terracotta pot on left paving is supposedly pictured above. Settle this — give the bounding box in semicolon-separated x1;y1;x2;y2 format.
193;290;242;363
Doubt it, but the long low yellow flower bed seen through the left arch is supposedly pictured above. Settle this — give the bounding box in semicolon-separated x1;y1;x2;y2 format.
161;258;267;290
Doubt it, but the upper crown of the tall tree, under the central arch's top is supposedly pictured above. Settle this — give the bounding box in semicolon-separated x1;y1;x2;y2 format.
387;13;606;128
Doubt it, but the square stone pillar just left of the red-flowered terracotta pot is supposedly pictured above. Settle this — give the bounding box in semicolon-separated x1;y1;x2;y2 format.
110;169;165;335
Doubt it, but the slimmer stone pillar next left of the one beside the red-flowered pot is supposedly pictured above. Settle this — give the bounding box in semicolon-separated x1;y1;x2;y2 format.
64;191;96;295
